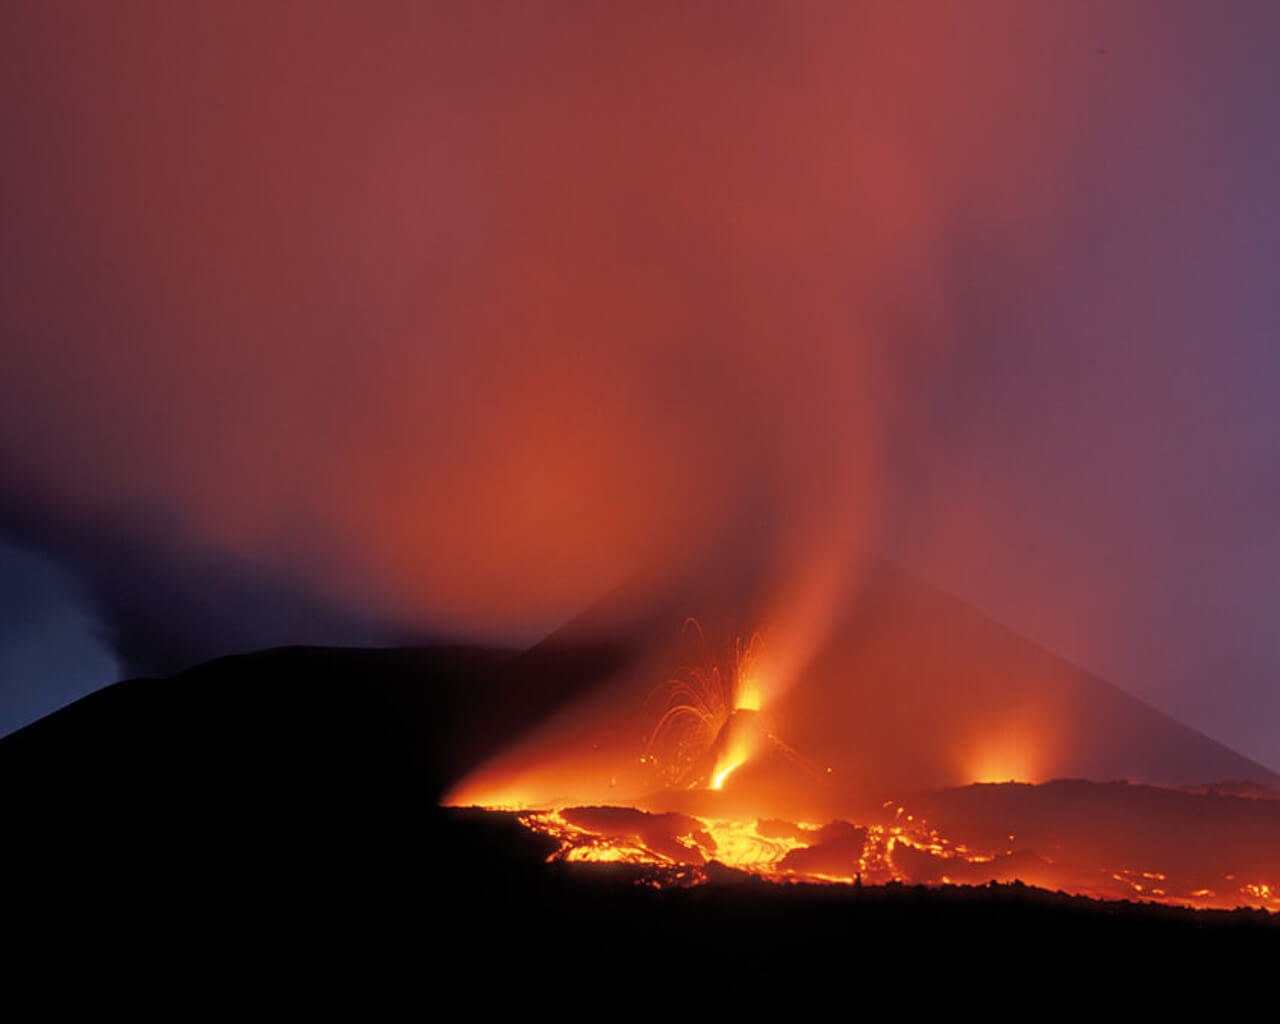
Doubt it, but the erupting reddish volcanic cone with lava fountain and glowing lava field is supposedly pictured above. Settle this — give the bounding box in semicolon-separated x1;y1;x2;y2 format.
447;562;1280;910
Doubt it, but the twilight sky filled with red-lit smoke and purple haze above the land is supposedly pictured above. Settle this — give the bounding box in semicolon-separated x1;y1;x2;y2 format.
0;0;1280;768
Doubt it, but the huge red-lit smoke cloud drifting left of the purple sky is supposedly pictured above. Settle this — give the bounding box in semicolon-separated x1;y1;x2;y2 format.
0;4;1100;655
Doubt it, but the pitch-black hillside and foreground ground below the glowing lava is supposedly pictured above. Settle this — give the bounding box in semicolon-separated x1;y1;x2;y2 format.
0;649;1280;998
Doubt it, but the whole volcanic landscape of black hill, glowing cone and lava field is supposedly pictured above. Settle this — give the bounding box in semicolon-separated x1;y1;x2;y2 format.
0;563;1280;988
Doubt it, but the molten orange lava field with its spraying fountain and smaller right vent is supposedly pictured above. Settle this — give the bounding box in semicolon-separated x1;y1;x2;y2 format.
451;620;1280;911
